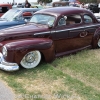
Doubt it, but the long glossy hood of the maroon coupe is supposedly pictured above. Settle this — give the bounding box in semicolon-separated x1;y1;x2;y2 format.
0;23;48;37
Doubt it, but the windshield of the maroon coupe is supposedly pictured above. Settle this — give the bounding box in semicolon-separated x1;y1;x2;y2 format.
30;14;55;25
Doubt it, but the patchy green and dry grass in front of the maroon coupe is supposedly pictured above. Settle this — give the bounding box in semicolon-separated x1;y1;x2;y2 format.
0;49;100;100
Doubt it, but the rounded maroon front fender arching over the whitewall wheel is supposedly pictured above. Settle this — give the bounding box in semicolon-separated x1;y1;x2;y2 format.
4;38;55;64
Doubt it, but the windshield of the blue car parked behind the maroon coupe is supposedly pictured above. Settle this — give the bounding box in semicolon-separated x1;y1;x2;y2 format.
1;9;21;21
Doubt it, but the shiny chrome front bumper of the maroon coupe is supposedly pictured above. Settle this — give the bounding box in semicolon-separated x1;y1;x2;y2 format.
0;53;19;71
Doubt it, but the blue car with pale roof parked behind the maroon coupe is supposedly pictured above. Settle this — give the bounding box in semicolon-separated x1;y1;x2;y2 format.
0;8;40;29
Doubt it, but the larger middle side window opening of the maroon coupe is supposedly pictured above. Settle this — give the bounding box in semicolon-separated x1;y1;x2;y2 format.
66;15;82;25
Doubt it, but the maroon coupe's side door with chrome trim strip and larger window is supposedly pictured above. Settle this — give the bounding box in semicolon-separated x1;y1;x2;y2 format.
54;15;87;53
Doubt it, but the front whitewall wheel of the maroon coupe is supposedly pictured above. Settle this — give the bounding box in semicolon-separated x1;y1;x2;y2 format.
20;51;41;69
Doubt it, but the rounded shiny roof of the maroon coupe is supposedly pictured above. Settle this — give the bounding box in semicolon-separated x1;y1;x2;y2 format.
36;6;90;15
